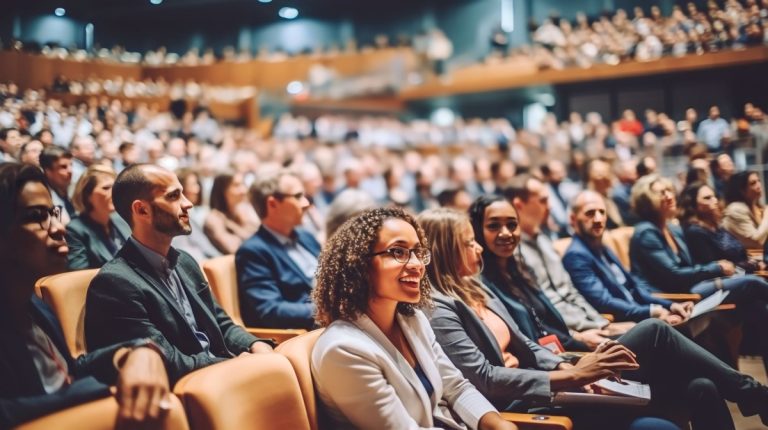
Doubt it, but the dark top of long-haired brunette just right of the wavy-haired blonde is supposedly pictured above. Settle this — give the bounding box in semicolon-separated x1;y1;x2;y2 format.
685;224;757;272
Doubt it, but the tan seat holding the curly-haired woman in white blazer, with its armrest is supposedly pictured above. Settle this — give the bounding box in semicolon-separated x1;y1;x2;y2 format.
276;329;573;430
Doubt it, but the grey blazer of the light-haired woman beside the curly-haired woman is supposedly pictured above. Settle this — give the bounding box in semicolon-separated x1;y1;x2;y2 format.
430;289;564;410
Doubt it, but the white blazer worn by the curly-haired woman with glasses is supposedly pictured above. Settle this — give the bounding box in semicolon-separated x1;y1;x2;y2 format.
312;311;495;430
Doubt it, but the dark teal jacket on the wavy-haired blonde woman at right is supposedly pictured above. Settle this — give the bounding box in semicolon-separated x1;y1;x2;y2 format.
629;221;723;293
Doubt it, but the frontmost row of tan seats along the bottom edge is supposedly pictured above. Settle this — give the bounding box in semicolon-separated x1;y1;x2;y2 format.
18;329;572;430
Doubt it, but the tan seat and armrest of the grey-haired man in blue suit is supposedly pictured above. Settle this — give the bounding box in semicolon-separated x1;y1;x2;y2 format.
202;255;307;343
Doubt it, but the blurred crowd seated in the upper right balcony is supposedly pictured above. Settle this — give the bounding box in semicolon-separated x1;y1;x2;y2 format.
531;0;768;69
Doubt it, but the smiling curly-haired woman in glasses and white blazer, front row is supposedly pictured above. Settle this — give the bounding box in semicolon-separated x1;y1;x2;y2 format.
311;208;517;429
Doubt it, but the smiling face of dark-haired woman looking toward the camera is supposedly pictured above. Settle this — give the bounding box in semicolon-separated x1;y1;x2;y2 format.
483;200;520;258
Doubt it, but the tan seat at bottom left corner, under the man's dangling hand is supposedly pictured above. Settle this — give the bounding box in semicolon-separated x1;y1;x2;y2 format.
16;395;189;430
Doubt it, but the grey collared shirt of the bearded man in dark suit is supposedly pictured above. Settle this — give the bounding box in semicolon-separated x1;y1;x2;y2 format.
129;236;213;356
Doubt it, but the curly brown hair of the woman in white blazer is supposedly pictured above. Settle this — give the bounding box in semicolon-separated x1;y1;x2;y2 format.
312;208;431;326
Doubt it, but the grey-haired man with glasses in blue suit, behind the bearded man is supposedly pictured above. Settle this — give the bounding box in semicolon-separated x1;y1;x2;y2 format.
235;171;320;328
